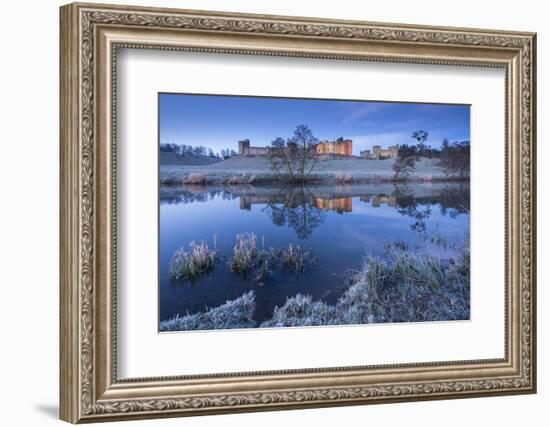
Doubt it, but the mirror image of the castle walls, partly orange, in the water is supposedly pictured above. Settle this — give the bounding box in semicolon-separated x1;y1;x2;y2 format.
239;194;397;213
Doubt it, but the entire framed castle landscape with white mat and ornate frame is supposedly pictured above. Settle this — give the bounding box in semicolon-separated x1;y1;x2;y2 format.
60;4;536;423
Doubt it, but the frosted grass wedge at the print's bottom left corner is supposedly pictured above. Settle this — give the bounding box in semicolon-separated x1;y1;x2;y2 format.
160;291;256;332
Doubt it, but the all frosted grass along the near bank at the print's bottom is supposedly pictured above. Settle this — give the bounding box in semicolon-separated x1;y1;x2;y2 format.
161;240;470;330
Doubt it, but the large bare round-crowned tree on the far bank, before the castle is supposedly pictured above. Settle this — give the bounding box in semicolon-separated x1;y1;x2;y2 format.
269;125;319;182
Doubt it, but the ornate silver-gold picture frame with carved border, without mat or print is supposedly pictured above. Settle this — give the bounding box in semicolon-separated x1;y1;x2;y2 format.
60;4;536;423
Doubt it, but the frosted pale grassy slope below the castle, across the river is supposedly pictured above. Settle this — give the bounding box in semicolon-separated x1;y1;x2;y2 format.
159;156;469;186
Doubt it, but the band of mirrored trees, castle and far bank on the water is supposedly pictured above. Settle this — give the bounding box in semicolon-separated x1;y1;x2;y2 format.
160;183;470;239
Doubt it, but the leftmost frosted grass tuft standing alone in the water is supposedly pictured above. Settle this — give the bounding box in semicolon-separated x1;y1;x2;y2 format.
168;241;218;280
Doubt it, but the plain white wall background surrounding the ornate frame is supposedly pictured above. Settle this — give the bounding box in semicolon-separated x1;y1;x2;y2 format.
0;0;550;427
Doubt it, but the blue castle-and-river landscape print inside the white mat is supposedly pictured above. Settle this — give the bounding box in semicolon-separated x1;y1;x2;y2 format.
158;93;470;332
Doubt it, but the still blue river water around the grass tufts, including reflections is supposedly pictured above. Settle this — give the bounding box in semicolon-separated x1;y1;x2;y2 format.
159;183;470;321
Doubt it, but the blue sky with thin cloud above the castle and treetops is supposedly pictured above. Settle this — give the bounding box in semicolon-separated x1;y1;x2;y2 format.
159;94;470;154
